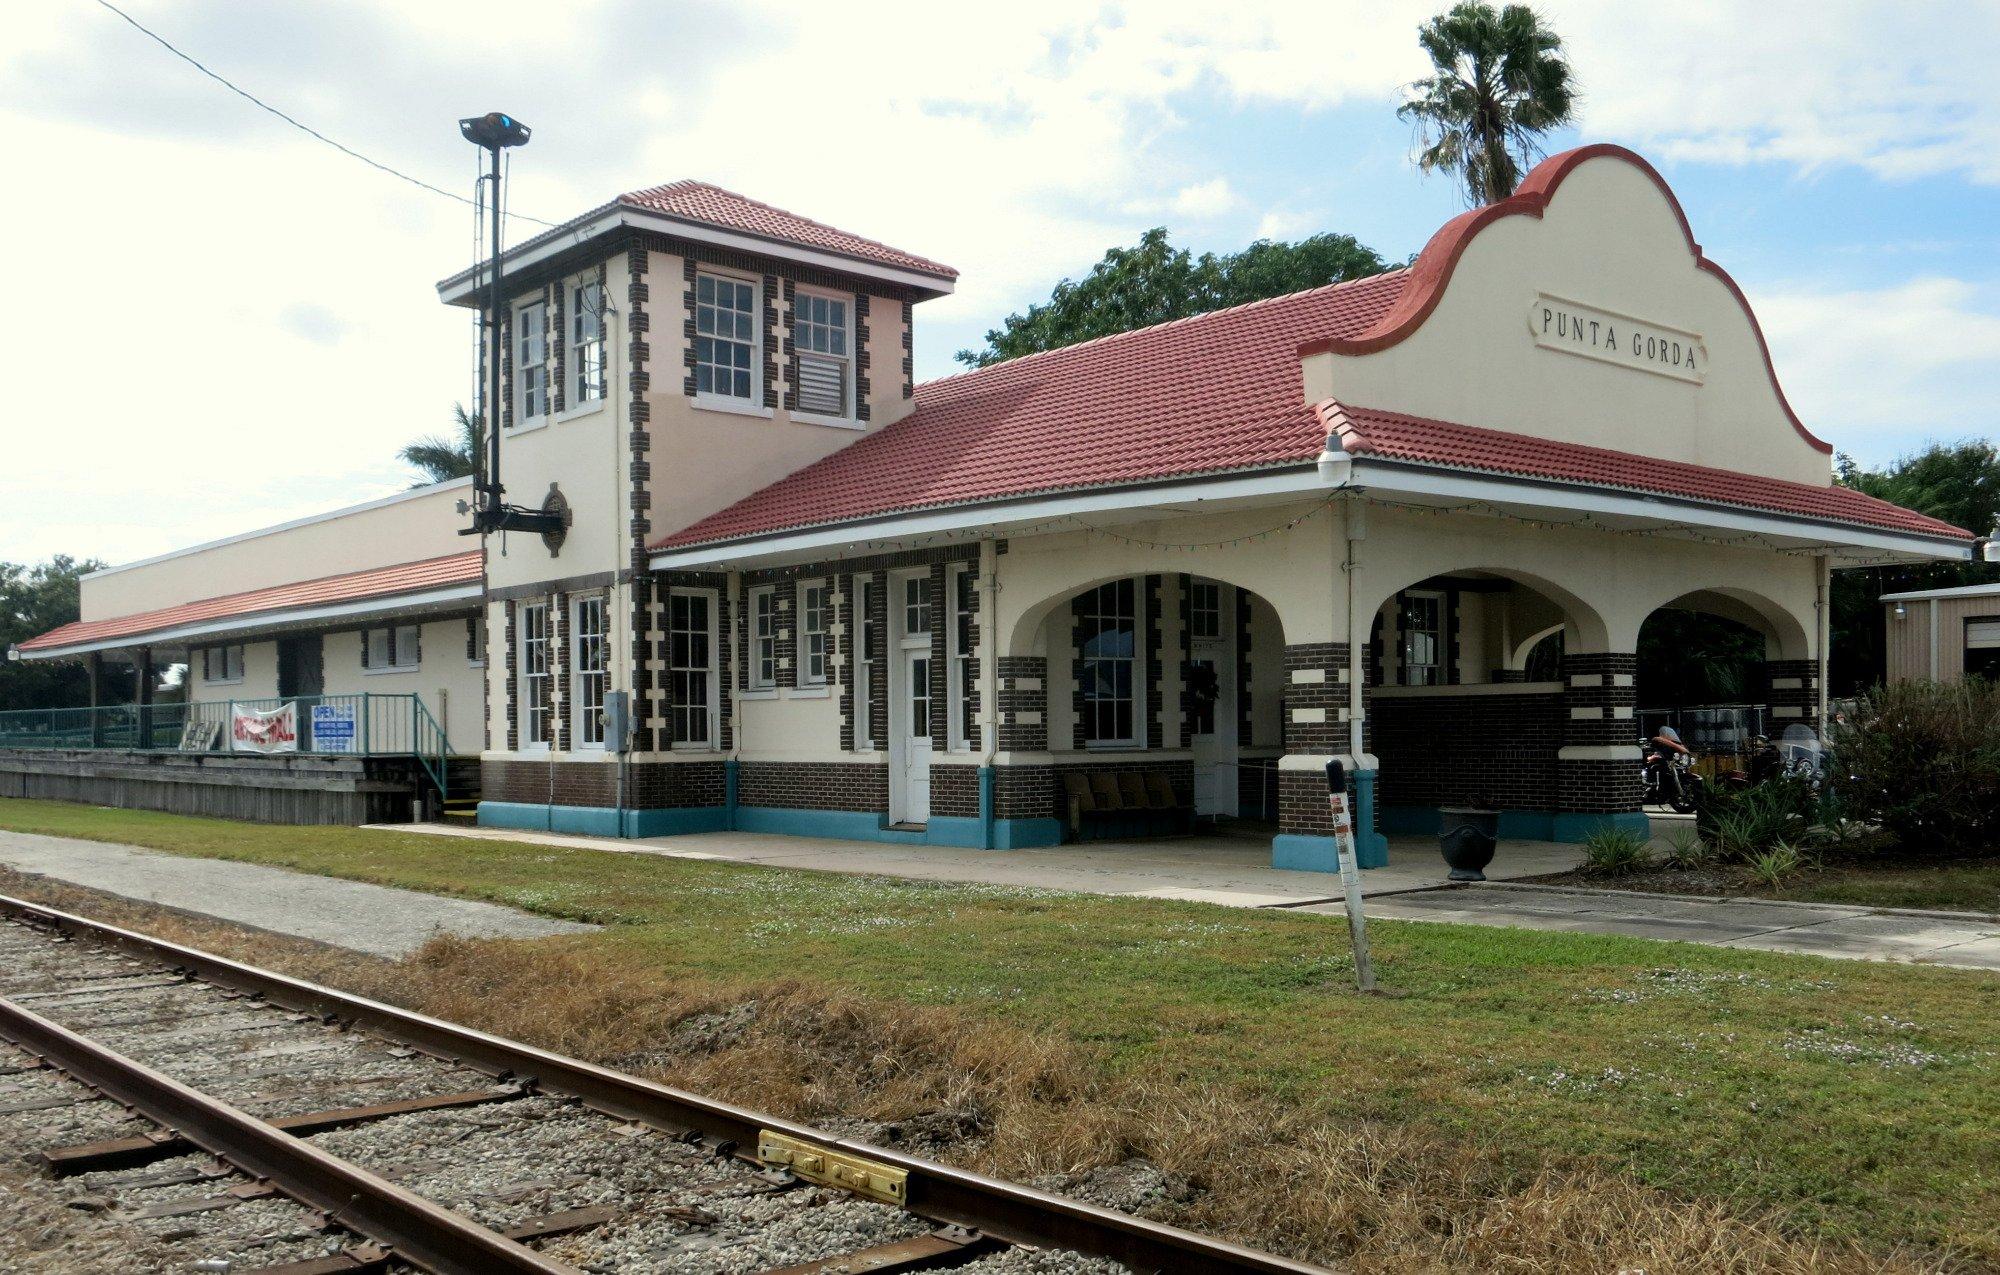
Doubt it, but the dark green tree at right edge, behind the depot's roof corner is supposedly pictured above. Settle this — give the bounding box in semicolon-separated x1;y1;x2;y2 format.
1828;440;2000;695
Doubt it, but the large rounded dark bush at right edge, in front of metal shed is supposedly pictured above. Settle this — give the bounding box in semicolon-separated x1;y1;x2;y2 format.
1828;677;2000;851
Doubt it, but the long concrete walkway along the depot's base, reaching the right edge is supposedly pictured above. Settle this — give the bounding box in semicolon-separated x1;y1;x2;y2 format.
380;823;2000;969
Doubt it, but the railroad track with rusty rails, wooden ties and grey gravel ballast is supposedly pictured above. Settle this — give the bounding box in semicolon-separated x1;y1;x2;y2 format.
0;895;1318;1275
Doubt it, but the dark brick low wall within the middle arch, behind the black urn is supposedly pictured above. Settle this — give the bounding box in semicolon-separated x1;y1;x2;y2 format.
1370;693;1564;809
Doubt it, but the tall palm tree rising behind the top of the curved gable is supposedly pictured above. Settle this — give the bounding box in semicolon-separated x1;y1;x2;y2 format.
1396;0;1576;208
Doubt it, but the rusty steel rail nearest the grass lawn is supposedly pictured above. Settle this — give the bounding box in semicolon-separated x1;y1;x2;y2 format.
0;895;1324;1275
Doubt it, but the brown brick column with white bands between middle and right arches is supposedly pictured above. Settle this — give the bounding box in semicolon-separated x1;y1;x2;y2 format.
1554;651;1648;841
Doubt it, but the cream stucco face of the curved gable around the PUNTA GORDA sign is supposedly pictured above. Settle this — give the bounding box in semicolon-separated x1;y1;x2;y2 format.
1304;158;1830;484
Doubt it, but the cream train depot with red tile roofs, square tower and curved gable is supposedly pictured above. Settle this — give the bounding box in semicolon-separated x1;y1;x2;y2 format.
7;146;1976;869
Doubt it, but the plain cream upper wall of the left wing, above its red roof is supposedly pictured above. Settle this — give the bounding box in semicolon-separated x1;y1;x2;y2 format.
82;482;478;620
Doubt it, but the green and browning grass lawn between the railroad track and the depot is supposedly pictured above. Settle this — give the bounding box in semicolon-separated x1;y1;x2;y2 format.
0;799;2000;1271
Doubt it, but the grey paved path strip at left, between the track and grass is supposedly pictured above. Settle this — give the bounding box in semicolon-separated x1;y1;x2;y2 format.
0;831;596;957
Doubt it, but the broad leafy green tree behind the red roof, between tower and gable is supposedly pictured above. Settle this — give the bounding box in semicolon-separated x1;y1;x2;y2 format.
958;228;1388;368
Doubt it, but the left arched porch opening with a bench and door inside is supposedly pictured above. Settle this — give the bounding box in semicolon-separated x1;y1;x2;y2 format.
1002;572;1286;839
